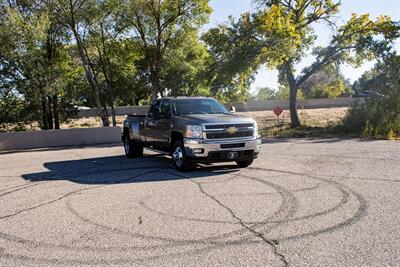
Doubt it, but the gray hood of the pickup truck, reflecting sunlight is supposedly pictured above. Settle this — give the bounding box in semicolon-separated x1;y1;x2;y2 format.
177;114;254;125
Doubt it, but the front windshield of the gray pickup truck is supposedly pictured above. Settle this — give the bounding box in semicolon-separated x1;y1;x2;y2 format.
174;99;229;116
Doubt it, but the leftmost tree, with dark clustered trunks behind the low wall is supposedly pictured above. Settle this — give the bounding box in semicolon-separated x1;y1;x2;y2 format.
0;0;66;130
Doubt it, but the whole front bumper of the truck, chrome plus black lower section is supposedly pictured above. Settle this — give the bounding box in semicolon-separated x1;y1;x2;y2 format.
184;137;261;161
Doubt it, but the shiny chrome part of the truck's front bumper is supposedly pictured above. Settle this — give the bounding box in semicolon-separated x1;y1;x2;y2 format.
183;137;261;157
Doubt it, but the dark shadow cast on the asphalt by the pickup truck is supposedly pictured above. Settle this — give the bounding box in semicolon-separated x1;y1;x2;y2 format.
22;154;238;184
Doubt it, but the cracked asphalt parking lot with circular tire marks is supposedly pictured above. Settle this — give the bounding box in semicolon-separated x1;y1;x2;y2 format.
0;139;400;266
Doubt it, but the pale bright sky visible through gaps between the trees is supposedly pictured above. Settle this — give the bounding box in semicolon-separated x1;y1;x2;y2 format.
202;0;400;93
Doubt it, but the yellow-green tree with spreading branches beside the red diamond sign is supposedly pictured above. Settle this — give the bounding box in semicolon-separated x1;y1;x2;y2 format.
205;0;399;127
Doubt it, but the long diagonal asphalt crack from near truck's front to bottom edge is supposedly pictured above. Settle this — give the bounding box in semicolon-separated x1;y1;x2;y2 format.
189;179;289;266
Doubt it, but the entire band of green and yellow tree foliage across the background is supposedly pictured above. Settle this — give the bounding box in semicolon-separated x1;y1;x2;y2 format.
0;0;400;132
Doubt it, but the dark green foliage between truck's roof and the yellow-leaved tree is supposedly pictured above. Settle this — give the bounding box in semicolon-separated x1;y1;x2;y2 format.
202;13;262;101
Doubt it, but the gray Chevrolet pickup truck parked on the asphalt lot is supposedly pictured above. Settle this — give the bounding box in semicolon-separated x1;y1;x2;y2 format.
122;97;261;171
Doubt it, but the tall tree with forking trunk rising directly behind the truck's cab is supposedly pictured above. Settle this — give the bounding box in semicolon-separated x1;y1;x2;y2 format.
118;0;211;99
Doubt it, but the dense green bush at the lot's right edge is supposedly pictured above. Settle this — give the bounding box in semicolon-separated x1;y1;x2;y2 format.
344;55;400;139
